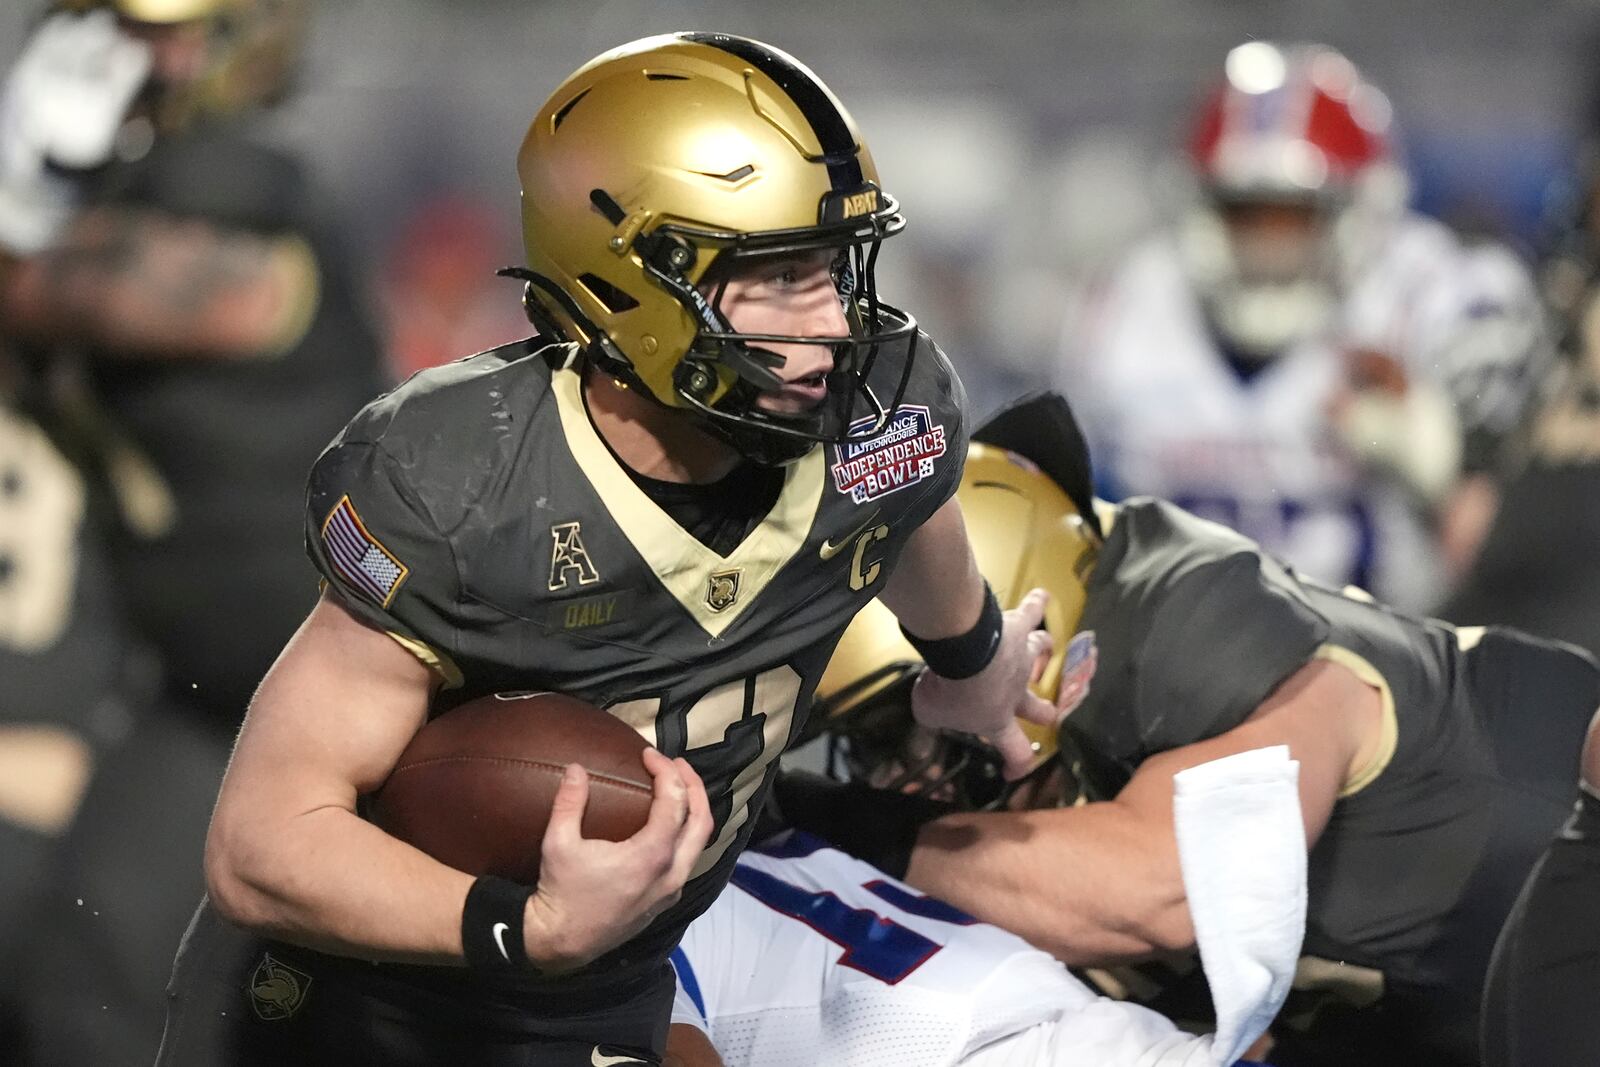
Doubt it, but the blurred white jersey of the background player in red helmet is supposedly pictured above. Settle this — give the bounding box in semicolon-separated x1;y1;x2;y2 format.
1058;216;1533;608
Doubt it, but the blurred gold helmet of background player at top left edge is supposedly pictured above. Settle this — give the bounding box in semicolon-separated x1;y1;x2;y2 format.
59;0;310;133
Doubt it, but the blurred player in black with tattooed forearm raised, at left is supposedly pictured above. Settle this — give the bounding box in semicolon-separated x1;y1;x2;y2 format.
0;0;384;1064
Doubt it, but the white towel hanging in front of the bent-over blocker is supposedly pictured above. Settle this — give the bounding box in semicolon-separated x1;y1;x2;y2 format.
1173;745;1306;1067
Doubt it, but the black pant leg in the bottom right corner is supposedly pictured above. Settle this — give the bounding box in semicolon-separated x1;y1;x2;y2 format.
1483;793;1600;1067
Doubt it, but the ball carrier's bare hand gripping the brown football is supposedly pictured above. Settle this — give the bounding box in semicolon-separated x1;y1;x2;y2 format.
523;749;712;971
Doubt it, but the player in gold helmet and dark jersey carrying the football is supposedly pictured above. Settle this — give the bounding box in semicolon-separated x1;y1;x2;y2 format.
160;32;1053;1067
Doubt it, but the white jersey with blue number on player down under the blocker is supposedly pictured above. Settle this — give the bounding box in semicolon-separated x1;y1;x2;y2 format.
672;833;1213;1067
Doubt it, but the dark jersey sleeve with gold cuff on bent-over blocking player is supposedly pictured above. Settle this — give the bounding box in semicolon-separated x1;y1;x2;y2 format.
1134;552;1328;753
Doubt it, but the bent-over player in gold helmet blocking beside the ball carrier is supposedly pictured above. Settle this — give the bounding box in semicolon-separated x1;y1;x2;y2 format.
776;397;1600;1064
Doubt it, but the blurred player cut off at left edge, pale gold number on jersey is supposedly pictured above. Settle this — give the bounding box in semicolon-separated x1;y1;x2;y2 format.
0;388;144;1064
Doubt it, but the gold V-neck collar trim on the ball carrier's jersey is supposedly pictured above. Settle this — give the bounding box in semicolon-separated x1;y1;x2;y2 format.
550;366;827;637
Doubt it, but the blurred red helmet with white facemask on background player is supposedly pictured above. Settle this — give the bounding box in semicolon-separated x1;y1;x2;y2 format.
1179;42;1406;360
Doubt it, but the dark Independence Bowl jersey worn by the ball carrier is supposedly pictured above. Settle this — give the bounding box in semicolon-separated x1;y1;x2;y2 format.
307;339;966;987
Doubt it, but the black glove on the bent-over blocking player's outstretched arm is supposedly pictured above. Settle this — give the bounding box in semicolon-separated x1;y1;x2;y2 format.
752;771;955;878
